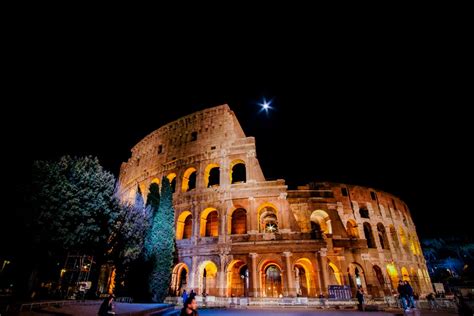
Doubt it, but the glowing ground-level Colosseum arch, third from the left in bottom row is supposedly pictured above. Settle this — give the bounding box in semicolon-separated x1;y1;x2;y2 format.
226;260;250;296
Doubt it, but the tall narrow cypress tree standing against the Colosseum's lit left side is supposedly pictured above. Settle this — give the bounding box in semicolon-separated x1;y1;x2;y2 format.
145;177;175;302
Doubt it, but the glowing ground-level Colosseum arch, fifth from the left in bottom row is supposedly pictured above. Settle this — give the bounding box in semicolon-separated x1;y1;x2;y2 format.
293;258;317;297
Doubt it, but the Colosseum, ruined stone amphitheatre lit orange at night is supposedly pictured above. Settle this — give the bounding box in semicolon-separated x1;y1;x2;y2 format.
119;105;432;300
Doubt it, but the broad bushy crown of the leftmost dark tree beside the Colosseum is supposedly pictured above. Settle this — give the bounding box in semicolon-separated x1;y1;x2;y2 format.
32;156;119;255
